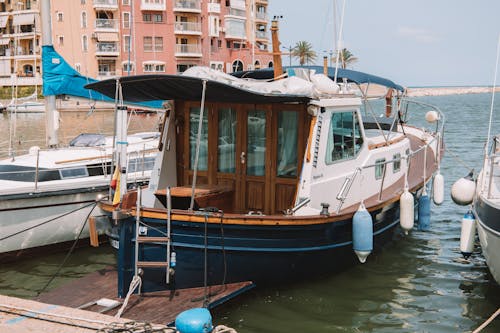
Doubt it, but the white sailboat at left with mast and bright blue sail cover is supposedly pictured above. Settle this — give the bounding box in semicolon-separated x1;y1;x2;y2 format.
0;0;161;261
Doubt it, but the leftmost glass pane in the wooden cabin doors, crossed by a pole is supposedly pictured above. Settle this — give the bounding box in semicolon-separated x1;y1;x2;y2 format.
189;107;208;171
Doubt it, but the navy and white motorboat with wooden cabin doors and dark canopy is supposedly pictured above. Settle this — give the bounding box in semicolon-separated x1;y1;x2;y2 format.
87;18;444;297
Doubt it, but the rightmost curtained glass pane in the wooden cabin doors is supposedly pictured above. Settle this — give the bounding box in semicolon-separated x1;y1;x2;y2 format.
276;111;299;177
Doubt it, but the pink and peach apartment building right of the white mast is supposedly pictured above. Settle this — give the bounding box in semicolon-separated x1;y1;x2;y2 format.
51;0;272;79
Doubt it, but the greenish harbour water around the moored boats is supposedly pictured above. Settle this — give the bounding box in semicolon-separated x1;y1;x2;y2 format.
0;94;500;333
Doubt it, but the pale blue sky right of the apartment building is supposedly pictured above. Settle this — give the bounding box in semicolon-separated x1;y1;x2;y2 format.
267;0;500;87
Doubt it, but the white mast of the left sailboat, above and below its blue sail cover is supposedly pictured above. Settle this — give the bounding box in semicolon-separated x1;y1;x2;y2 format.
40;0;59;147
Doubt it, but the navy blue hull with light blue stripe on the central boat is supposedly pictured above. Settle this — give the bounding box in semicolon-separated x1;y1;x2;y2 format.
111;198;408;297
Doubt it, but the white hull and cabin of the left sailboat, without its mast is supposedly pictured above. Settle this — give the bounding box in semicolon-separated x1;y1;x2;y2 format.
0;132;159;262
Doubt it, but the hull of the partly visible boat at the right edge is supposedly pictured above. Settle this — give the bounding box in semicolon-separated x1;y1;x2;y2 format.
474;196;500;284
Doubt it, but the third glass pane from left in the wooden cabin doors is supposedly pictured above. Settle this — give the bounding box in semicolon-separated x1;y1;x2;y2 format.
247;110;266;176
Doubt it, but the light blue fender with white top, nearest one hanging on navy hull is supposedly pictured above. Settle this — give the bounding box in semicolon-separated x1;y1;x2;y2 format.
352;204;373;263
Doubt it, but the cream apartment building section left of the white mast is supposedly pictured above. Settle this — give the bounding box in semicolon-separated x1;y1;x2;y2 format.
0;0;42;86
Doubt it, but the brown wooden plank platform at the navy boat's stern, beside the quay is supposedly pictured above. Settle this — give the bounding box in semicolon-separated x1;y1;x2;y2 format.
36;268;255;324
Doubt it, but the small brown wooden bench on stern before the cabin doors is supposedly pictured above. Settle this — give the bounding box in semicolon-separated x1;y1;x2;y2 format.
155;184;234;212
